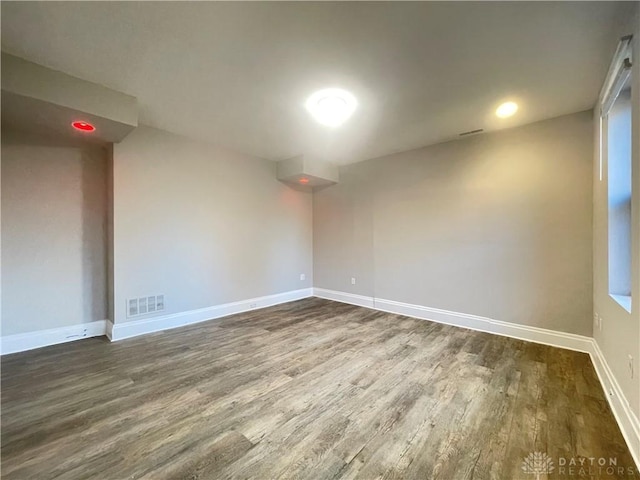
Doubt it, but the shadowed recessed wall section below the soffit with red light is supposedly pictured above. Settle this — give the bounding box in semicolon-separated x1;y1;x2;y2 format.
2;130;107;336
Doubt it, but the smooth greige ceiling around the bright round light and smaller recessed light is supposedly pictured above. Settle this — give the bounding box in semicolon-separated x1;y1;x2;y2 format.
2;2;633;163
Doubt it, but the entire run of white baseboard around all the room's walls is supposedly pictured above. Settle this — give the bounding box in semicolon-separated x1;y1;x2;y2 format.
0;288;640;469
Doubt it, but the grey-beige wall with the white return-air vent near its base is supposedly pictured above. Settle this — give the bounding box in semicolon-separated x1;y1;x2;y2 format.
113;127;313;324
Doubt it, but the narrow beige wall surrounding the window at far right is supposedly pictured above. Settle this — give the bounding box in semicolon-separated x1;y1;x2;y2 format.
593;4;640;432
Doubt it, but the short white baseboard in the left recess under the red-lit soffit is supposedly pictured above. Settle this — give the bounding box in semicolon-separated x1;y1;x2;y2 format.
0;320;107;355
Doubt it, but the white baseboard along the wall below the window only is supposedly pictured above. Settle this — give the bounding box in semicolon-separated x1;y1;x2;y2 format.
589;339;640;470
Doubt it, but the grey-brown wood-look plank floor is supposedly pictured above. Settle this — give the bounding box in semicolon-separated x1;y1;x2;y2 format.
1;298;640;480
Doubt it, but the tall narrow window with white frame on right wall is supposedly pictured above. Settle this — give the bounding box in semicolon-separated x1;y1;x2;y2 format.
600;33;632;312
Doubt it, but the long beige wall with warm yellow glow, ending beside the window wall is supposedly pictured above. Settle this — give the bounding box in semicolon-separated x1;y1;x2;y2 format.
313;112;593;335
